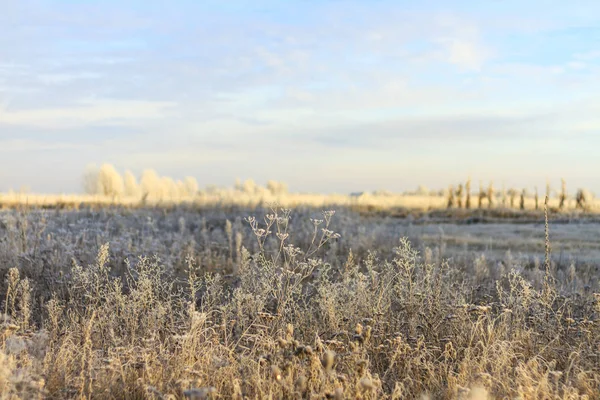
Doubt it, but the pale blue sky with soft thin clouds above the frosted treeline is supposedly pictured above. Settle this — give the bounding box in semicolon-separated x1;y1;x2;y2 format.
0;0;600;194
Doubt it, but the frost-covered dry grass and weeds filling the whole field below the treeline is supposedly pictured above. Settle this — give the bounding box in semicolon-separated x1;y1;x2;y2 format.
0;204;600;399
